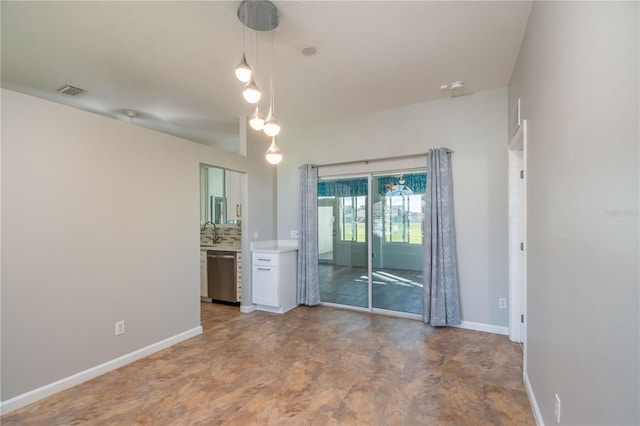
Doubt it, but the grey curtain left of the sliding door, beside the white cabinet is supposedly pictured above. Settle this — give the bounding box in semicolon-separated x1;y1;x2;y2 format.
298;164;320;306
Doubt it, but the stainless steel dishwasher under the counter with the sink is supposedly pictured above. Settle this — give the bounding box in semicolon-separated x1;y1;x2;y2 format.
207;250;238;304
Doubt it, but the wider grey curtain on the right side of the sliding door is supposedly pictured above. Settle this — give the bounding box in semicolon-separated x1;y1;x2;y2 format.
422;148;460;326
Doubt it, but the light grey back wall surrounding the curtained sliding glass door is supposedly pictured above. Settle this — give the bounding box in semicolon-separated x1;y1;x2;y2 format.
277;88;508;327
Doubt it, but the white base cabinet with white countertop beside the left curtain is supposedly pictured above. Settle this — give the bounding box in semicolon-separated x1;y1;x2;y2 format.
251;250;298;313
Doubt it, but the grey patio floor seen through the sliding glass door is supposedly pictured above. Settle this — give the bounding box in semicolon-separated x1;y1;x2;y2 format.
318;263;422;314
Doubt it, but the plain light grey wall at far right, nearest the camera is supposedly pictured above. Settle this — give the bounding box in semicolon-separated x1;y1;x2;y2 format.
509;2;640;425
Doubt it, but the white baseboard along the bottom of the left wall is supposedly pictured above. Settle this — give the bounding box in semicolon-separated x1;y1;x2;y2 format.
0;326;202;414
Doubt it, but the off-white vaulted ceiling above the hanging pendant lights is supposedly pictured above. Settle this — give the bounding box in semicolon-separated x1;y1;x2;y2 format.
1;1;531;150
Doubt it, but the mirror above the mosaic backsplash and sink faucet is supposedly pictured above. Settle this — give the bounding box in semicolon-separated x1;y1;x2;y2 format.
200;165;242;225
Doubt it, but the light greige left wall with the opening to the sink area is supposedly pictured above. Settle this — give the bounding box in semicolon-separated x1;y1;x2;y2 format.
1;90;274;401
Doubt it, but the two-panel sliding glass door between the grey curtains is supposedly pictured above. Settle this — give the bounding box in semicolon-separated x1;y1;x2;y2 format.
318;173;426;314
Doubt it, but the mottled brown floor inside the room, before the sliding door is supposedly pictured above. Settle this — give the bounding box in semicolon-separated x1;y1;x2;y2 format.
0;303;535;426
